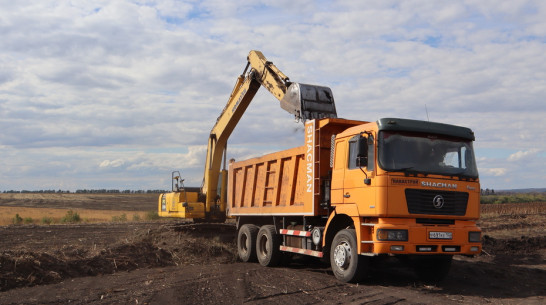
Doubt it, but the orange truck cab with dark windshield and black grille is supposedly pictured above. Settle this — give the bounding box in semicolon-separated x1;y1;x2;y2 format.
324;118;481;276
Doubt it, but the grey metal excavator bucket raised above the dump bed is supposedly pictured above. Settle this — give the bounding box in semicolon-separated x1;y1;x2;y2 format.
281;83;337;122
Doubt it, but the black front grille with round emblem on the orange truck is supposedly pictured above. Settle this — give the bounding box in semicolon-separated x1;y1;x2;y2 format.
406;189;468;216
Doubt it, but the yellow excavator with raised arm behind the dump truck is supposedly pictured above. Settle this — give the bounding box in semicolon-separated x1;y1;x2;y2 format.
158;51;337;222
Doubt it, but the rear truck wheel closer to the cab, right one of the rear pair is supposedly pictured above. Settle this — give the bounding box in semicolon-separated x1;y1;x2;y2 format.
256;225;282;267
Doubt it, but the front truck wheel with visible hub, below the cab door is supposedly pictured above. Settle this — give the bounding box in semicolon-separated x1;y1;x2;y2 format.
330;229;369;283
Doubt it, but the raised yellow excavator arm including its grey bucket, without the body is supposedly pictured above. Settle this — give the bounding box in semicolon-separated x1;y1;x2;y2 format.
201;51;337;217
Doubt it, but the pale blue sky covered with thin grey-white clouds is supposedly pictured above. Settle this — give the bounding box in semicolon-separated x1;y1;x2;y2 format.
0;0;546;191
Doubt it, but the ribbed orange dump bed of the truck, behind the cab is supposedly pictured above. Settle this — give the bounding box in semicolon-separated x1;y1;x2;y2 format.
227;118;366;216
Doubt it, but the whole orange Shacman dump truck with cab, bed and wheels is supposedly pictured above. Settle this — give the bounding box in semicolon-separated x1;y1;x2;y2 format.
226;118;481;282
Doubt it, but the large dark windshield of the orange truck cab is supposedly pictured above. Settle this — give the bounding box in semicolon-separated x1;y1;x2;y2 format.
378;131;478;178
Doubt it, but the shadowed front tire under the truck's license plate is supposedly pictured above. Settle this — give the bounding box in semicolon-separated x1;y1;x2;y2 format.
413;255;453;284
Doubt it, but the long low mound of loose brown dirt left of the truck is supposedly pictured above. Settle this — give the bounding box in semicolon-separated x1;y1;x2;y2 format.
0;226;236;291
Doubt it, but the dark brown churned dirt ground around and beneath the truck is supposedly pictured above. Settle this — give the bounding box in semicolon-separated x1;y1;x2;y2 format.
0;194;546;304
